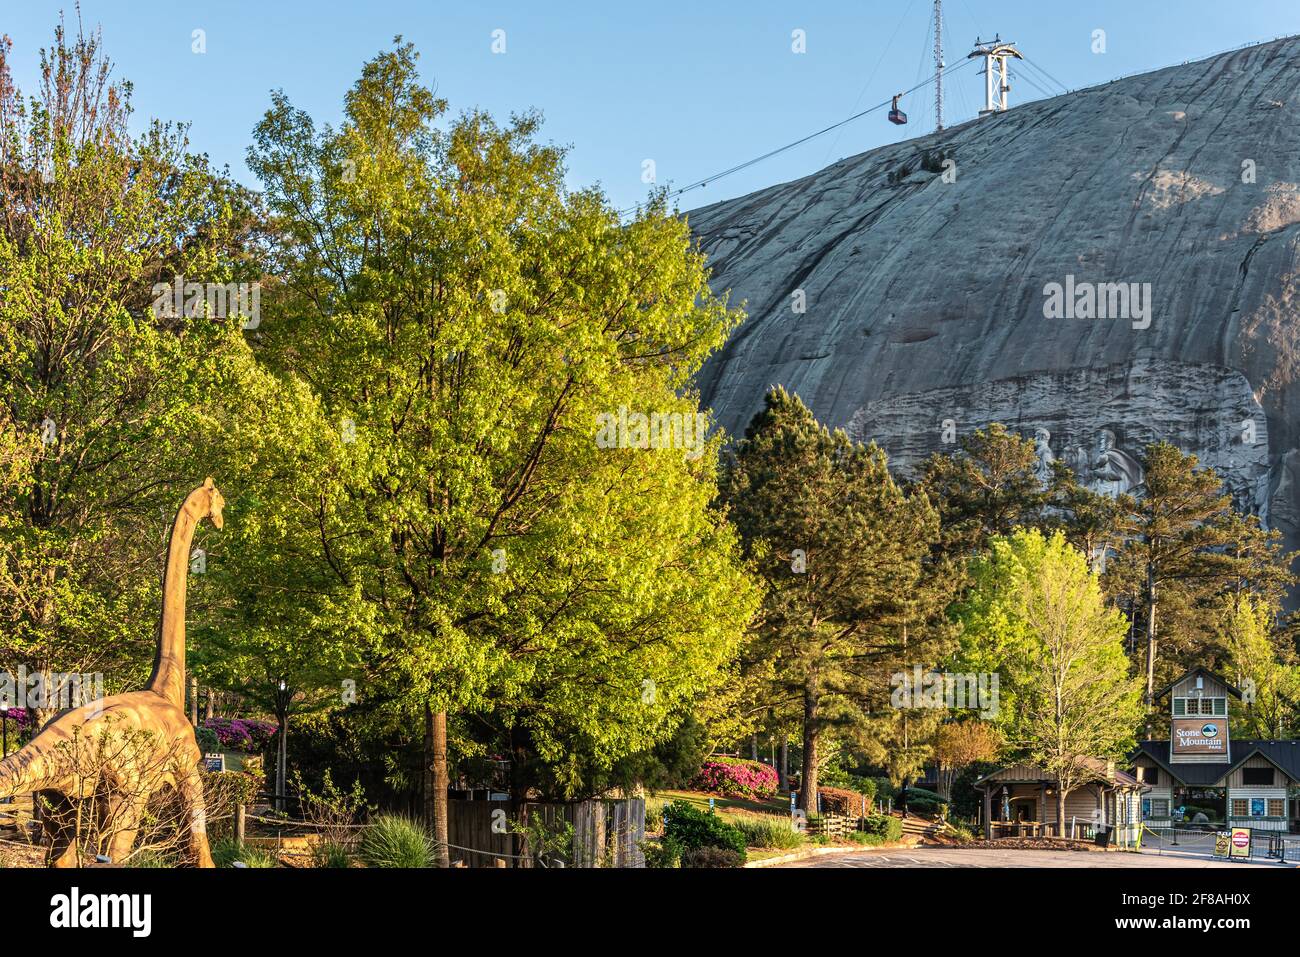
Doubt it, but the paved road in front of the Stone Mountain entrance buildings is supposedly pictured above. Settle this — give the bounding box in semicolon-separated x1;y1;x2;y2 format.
776;848;1282;870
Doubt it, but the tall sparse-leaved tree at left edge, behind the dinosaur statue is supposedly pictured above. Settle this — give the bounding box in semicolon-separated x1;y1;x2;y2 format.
0;14;266;713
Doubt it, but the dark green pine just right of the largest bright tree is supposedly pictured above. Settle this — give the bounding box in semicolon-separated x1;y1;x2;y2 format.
723;389;950;811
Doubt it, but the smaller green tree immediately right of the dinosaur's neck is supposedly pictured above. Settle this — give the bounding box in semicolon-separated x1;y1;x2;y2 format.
190;381;369;806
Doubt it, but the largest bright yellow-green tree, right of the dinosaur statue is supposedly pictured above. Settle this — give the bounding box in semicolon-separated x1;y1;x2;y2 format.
250;43;755;858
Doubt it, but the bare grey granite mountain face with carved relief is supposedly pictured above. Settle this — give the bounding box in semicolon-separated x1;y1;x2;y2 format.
689;38;1300;547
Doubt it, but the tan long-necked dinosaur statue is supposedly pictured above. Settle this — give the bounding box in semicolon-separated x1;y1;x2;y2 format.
0;479;225;867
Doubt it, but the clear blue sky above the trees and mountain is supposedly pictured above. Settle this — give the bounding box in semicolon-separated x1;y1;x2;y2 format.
0;0;1300;209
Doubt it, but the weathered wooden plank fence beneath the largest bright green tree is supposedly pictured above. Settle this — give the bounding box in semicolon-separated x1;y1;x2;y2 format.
447;797;646;867
